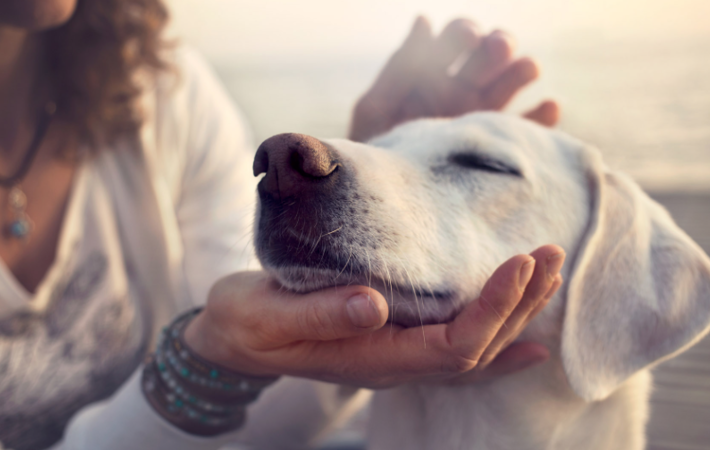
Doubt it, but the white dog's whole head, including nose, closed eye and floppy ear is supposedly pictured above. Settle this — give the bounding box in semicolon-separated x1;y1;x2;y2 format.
254;113;710;399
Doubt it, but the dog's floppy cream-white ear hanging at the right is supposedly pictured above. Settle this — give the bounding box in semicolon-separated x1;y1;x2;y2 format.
562;151;710;401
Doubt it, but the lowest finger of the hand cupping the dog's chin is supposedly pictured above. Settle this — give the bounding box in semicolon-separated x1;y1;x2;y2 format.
449;342;550;384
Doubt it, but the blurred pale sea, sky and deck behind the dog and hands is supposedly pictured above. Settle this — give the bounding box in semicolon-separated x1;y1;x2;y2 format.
168;0;710;450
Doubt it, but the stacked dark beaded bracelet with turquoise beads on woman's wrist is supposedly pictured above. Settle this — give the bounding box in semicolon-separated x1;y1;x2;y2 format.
142;308;278;436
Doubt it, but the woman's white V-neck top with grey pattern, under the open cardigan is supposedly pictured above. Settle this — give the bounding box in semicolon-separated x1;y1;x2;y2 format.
0;163;152;449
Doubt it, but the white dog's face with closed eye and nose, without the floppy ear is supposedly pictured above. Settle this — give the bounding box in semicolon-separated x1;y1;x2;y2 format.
255;114;590;326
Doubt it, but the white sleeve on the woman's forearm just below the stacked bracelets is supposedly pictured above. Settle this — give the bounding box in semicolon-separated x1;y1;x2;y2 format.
51;369;367;450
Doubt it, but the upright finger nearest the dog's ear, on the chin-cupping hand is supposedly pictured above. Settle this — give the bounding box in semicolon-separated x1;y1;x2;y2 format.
479;245;565;365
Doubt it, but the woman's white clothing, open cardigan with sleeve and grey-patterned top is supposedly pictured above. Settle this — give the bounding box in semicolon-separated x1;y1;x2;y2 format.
0;49;355;450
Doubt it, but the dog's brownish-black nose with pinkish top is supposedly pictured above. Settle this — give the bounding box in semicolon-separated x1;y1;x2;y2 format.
254;133;339;198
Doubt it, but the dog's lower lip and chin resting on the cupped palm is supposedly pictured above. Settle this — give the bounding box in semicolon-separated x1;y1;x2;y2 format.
266;266;464;327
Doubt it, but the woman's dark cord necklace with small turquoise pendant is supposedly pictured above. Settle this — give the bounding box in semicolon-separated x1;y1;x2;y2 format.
0;102;57;240
